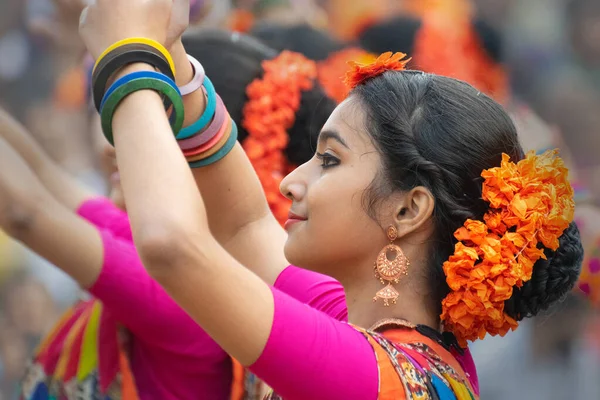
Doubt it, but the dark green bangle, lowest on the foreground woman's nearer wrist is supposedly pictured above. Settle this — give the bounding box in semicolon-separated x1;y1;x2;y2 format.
100;77;184;146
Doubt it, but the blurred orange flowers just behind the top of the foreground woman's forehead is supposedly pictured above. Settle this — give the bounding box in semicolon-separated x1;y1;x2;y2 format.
317;47;377;103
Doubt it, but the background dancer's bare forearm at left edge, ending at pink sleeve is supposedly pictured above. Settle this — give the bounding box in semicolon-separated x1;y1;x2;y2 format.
0;137;102;288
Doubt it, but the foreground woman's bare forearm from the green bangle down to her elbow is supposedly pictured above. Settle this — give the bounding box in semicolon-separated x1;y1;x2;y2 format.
113;64;208;242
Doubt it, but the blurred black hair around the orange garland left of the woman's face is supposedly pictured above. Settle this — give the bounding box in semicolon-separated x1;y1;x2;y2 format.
183;29;335;164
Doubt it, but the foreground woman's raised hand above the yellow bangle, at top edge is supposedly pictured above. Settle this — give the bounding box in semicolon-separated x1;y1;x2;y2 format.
79;0;172;59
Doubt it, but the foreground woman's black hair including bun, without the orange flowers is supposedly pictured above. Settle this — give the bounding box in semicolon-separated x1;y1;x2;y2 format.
350;71;583;318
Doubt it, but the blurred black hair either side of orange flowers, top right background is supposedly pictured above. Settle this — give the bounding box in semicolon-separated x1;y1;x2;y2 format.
358;16;503;62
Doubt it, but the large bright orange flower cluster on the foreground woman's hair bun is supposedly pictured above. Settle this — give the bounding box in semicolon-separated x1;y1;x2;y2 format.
441;150;575;346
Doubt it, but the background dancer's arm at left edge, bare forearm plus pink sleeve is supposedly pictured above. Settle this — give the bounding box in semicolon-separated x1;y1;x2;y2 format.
0;134;214;346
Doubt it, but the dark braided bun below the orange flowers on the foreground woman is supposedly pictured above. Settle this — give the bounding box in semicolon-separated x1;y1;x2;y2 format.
504;222;583;321
